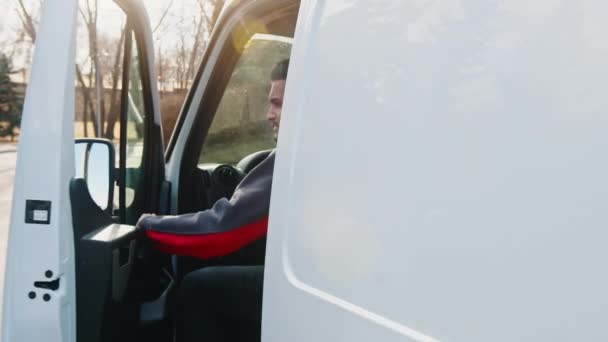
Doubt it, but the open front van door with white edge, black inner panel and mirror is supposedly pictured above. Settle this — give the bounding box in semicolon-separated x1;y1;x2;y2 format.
2;0;173;342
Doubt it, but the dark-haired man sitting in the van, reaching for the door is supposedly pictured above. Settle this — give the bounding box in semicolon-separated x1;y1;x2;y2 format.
137;60;289;342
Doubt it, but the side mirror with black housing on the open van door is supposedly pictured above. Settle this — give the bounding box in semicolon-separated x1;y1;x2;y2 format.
74;139;116;214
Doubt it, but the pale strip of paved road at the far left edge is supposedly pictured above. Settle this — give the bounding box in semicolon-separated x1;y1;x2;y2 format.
0;149;17;329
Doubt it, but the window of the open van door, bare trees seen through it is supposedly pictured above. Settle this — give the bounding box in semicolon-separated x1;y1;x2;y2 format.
74;5;149;222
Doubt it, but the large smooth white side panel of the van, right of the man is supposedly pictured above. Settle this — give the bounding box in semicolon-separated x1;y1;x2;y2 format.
263;0;608;342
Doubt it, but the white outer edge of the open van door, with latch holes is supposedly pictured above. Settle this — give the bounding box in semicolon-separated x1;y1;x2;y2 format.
2;0;77;342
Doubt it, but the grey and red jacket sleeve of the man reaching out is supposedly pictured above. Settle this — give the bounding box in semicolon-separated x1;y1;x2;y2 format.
137;152;275;259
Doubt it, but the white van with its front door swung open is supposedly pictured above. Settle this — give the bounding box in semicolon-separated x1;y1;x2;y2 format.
2;0;608;342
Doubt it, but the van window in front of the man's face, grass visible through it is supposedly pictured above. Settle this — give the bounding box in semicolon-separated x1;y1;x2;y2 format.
199;34;291;165
